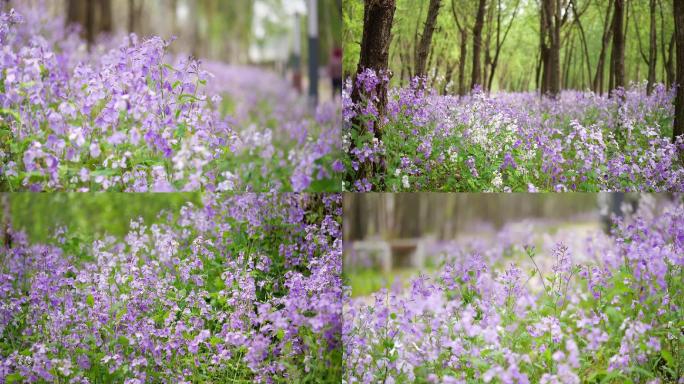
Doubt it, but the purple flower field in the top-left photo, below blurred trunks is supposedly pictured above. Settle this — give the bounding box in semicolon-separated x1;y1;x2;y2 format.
0;7;341;192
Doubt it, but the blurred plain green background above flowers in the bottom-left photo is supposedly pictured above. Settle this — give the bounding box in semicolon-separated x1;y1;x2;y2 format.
0;192;202;243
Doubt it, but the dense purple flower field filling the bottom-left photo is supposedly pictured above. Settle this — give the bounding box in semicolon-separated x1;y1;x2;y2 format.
0;194;342;383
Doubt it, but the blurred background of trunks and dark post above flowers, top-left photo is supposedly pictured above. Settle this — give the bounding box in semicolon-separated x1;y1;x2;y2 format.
0;0;342;100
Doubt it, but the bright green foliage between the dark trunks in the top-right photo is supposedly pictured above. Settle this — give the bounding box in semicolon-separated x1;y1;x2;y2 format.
342;0;674;93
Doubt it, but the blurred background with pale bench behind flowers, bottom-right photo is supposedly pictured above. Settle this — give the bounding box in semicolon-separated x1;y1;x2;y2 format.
343;193;674;297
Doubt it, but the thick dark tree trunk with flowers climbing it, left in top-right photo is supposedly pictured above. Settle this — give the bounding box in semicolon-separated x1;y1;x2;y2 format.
350;0;396;189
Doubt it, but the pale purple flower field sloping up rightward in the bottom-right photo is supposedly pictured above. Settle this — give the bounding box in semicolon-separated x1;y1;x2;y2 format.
342;196;684;384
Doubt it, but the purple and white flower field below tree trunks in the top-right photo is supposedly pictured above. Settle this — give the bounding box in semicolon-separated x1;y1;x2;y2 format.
343;70;684;192
